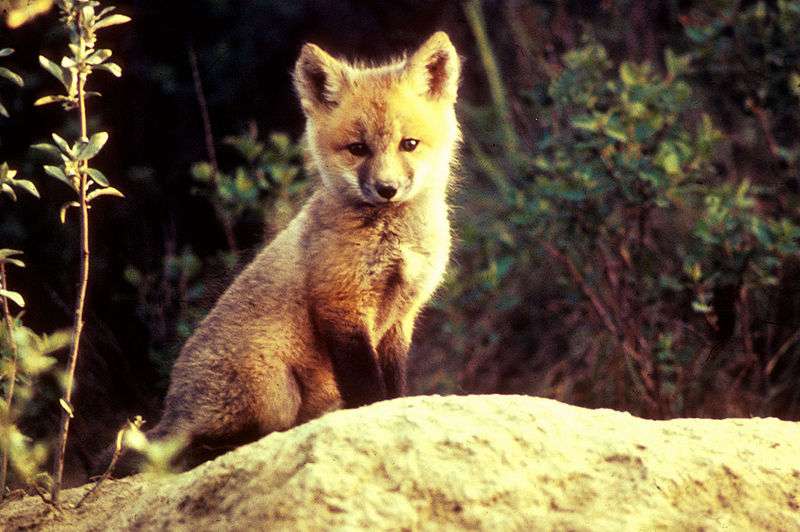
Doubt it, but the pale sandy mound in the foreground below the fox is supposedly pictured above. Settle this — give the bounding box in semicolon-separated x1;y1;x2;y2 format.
0;395;800;531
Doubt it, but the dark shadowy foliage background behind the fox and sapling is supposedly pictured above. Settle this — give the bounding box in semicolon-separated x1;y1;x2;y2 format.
0;0;800;488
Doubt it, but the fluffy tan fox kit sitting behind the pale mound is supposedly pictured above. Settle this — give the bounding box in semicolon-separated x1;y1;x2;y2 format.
105;32;460;470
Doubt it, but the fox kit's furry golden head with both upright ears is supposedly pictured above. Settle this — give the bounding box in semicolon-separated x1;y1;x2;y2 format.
294;32;460;205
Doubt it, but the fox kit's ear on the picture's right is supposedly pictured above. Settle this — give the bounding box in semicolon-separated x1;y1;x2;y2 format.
406;31;461;102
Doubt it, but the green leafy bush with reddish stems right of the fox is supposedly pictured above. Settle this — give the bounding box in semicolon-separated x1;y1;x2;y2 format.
442;13;800;417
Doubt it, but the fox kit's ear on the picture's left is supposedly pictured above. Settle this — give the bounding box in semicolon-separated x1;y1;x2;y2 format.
294;43;347;113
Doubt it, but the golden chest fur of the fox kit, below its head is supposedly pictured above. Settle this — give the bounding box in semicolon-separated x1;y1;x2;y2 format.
306;193;450;346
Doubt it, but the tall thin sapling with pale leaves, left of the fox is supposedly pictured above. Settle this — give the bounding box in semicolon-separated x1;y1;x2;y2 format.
35;0;130;506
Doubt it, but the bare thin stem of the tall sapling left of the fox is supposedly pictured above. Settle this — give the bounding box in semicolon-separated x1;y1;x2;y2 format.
50;23;89;506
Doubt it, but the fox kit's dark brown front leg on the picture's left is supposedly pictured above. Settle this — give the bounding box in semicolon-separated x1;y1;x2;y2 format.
314;313;386;408
